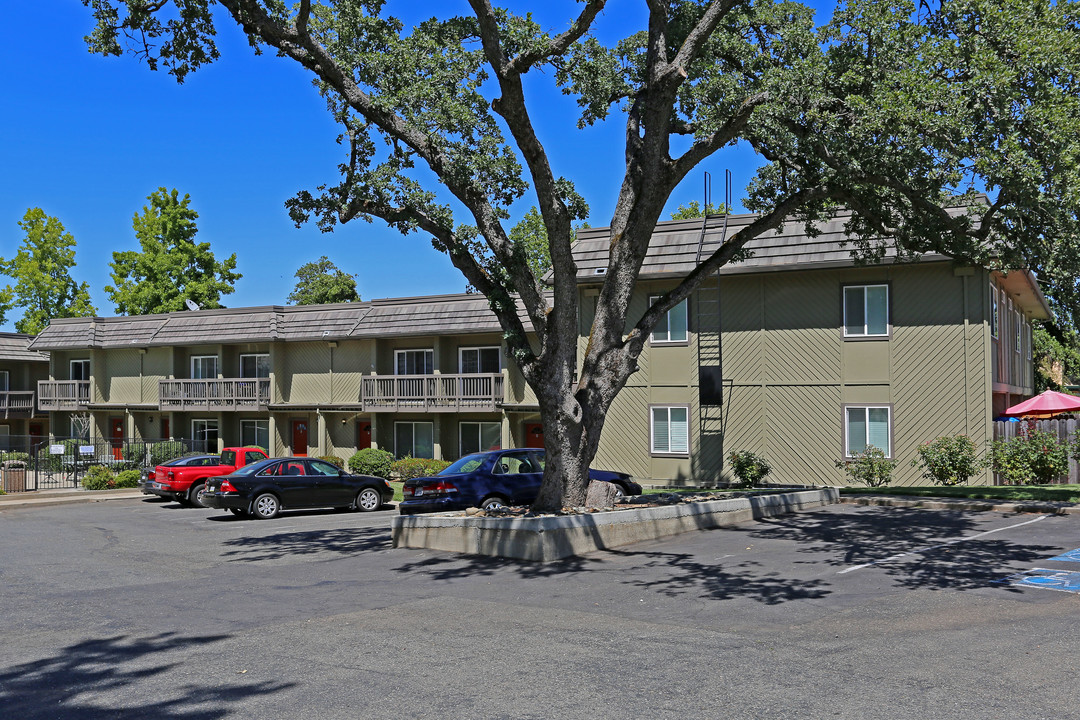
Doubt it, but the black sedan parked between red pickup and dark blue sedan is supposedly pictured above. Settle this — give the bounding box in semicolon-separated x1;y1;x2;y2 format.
202;458;394;519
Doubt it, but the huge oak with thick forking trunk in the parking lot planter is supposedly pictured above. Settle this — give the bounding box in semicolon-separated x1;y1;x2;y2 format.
84;0;1080;510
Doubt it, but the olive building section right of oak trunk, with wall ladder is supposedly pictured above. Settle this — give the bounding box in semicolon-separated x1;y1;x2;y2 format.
575;215;1050;484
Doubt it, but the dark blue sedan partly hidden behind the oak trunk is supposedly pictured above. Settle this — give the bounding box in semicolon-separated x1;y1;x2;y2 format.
397;449;642;515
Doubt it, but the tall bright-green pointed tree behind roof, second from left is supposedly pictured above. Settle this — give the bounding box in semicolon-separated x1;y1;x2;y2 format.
105;188;243;315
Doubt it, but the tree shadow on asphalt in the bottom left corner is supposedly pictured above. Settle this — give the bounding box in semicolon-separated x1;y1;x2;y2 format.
0;633;293;720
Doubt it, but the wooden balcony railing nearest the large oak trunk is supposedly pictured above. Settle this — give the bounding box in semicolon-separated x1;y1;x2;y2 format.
360;372;503;412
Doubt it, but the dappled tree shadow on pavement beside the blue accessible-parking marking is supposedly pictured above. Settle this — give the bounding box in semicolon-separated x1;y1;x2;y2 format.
750;507;1059;589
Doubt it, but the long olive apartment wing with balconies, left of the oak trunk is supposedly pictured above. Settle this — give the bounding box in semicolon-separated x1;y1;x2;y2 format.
33;295;536;458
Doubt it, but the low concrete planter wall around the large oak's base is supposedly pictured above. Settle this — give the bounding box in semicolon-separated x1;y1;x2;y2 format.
392;488;839;562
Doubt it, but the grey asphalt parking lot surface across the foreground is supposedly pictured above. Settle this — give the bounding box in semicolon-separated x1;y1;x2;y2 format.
0;500;1080;719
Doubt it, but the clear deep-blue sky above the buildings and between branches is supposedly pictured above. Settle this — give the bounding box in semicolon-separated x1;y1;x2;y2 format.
0;0;824;330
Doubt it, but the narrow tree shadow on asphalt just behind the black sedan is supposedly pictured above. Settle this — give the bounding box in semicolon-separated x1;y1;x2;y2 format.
221;528;390;562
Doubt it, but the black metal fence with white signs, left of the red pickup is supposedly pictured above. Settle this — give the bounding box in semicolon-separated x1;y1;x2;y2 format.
0;435;204;492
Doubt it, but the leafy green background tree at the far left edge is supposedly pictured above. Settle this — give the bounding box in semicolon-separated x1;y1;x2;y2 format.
0;207;97;335
